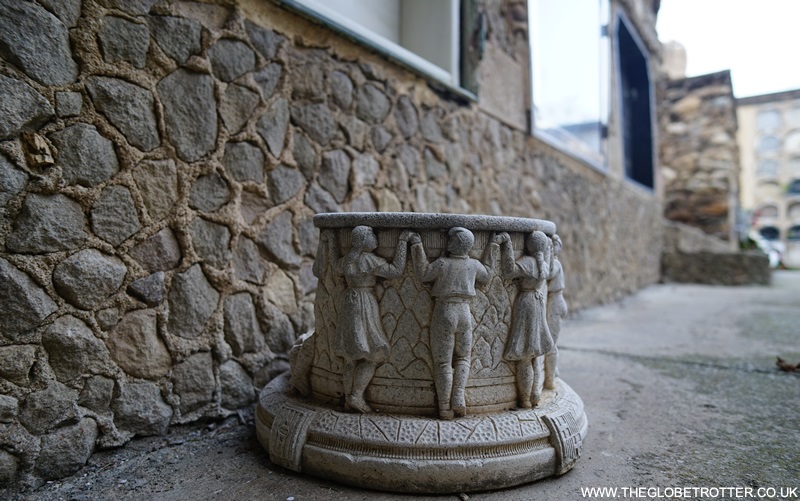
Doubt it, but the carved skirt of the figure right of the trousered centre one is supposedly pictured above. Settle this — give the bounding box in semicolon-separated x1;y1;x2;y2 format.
505;290;555;360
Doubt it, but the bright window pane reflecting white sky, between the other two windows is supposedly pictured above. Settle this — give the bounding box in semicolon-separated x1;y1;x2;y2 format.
529;0;608;165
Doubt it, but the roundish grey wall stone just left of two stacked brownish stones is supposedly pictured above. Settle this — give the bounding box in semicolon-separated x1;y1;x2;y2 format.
90;185;142;245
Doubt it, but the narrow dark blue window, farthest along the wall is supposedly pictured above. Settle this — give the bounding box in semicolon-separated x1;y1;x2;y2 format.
616;15;654;188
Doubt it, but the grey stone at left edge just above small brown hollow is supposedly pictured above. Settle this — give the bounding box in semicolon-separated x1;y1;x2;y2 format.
0;75;54;139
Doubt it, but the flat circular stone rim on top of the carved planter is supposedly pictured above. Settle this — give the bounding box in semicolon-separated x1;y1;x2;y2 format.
314;212;556;235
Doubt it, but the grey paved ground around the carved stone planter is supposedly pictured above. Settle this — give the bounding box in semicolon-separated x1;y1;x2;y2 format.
7;272;800;501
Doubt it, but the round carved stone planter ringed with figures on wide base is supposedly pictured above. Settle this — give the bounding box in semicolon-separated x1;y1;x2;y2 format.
256;213;587;493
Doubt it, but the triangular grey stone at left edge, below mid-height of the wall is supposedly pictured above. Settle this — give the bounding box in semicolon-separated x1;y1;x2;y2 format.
0;258;58;340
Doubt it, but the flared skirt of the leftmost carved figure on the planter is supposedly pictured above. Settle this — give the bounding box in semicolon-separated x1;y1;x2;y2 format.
334;287;389;363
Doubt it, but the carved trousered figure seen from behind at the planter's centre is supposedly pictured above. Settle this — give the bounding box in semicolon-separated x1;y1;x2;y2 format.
410;227;494;419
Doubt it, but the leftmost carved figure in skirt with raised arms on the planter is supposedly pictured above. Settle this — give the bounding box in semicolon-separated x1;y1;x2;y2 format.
315;226;408;412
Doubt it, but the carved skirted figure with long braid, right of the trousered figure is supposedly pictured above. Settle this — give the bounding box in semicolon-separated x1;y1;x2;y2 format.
496;231;554;409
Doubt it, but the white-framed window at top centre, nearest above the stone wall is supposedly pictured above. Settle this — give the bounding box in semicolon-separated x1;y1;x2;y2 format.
283;0;466;92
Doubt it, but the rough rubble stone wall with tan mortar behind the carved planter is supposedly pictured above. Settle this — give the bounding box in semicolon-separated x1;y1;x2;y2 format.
0;0;662;483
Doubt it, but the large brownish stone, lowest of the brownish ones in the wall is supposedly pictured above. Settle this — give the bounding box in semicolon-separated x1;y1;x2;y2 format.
106;310;172;379
